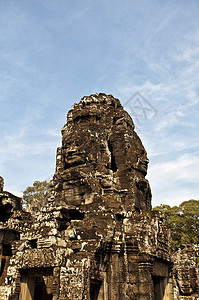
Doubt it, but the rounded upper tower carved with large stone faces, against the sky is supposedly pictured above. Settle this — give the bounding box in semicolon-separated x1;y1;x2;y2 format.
53;96;150;209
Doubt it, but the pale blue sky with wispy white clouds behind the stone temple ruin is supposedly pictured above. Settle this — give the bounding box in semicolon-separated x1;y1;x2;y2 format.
0;0;199;205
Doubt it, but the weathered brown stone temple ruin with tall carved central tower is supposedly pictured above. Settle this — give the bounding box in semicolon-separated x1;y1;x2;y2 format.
0;94;198;300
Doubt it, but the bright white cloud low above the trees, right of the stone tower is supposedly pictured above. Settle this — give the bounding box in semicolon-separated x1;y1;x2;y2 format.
148;153;199;205
